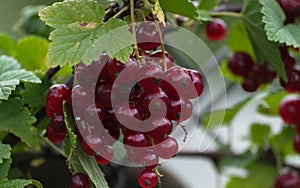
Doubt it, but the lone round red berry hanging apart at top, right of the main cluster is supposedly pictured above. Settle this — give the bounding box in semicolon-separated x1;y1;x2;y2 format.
205;18;227;41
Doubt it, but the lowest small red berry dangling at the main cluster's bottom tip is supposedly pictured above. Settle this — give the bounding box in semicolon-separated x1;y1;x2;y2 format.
138;168;158;188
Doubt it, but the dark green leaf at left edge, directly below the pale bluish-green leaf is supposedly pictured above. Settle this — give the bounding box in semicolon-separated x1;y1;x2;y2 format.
0;98;40;150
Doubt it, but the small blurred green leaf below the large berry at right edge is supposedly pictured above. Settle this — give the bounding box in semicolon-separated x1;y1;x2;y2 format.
270;126;295;156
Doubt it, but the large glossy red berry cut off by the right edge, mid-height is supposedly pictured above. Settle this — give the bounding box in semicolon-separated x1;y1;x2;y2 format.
279;96;300;125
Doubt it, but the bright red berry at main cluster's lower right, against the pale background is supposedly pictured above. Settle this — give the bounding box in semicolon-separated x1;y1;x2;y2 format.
154;137;178;159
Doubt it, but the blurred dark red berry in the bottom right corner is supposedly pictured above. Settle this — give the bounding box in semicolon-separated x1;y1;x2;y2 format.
274;172;300;188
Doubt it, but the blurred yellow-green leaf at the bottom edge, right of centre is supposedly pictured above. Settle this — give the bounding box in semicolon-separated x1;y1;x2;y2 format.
226;163;277;188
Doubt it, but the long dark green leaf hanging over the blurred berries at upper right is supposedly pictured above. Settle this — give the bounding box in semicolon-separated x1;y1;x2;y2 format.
242;0;287;80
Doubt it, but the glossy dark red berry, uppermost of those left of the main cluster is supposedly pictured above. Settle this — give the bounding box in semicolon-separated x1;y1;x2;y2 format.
46;84;71;117
